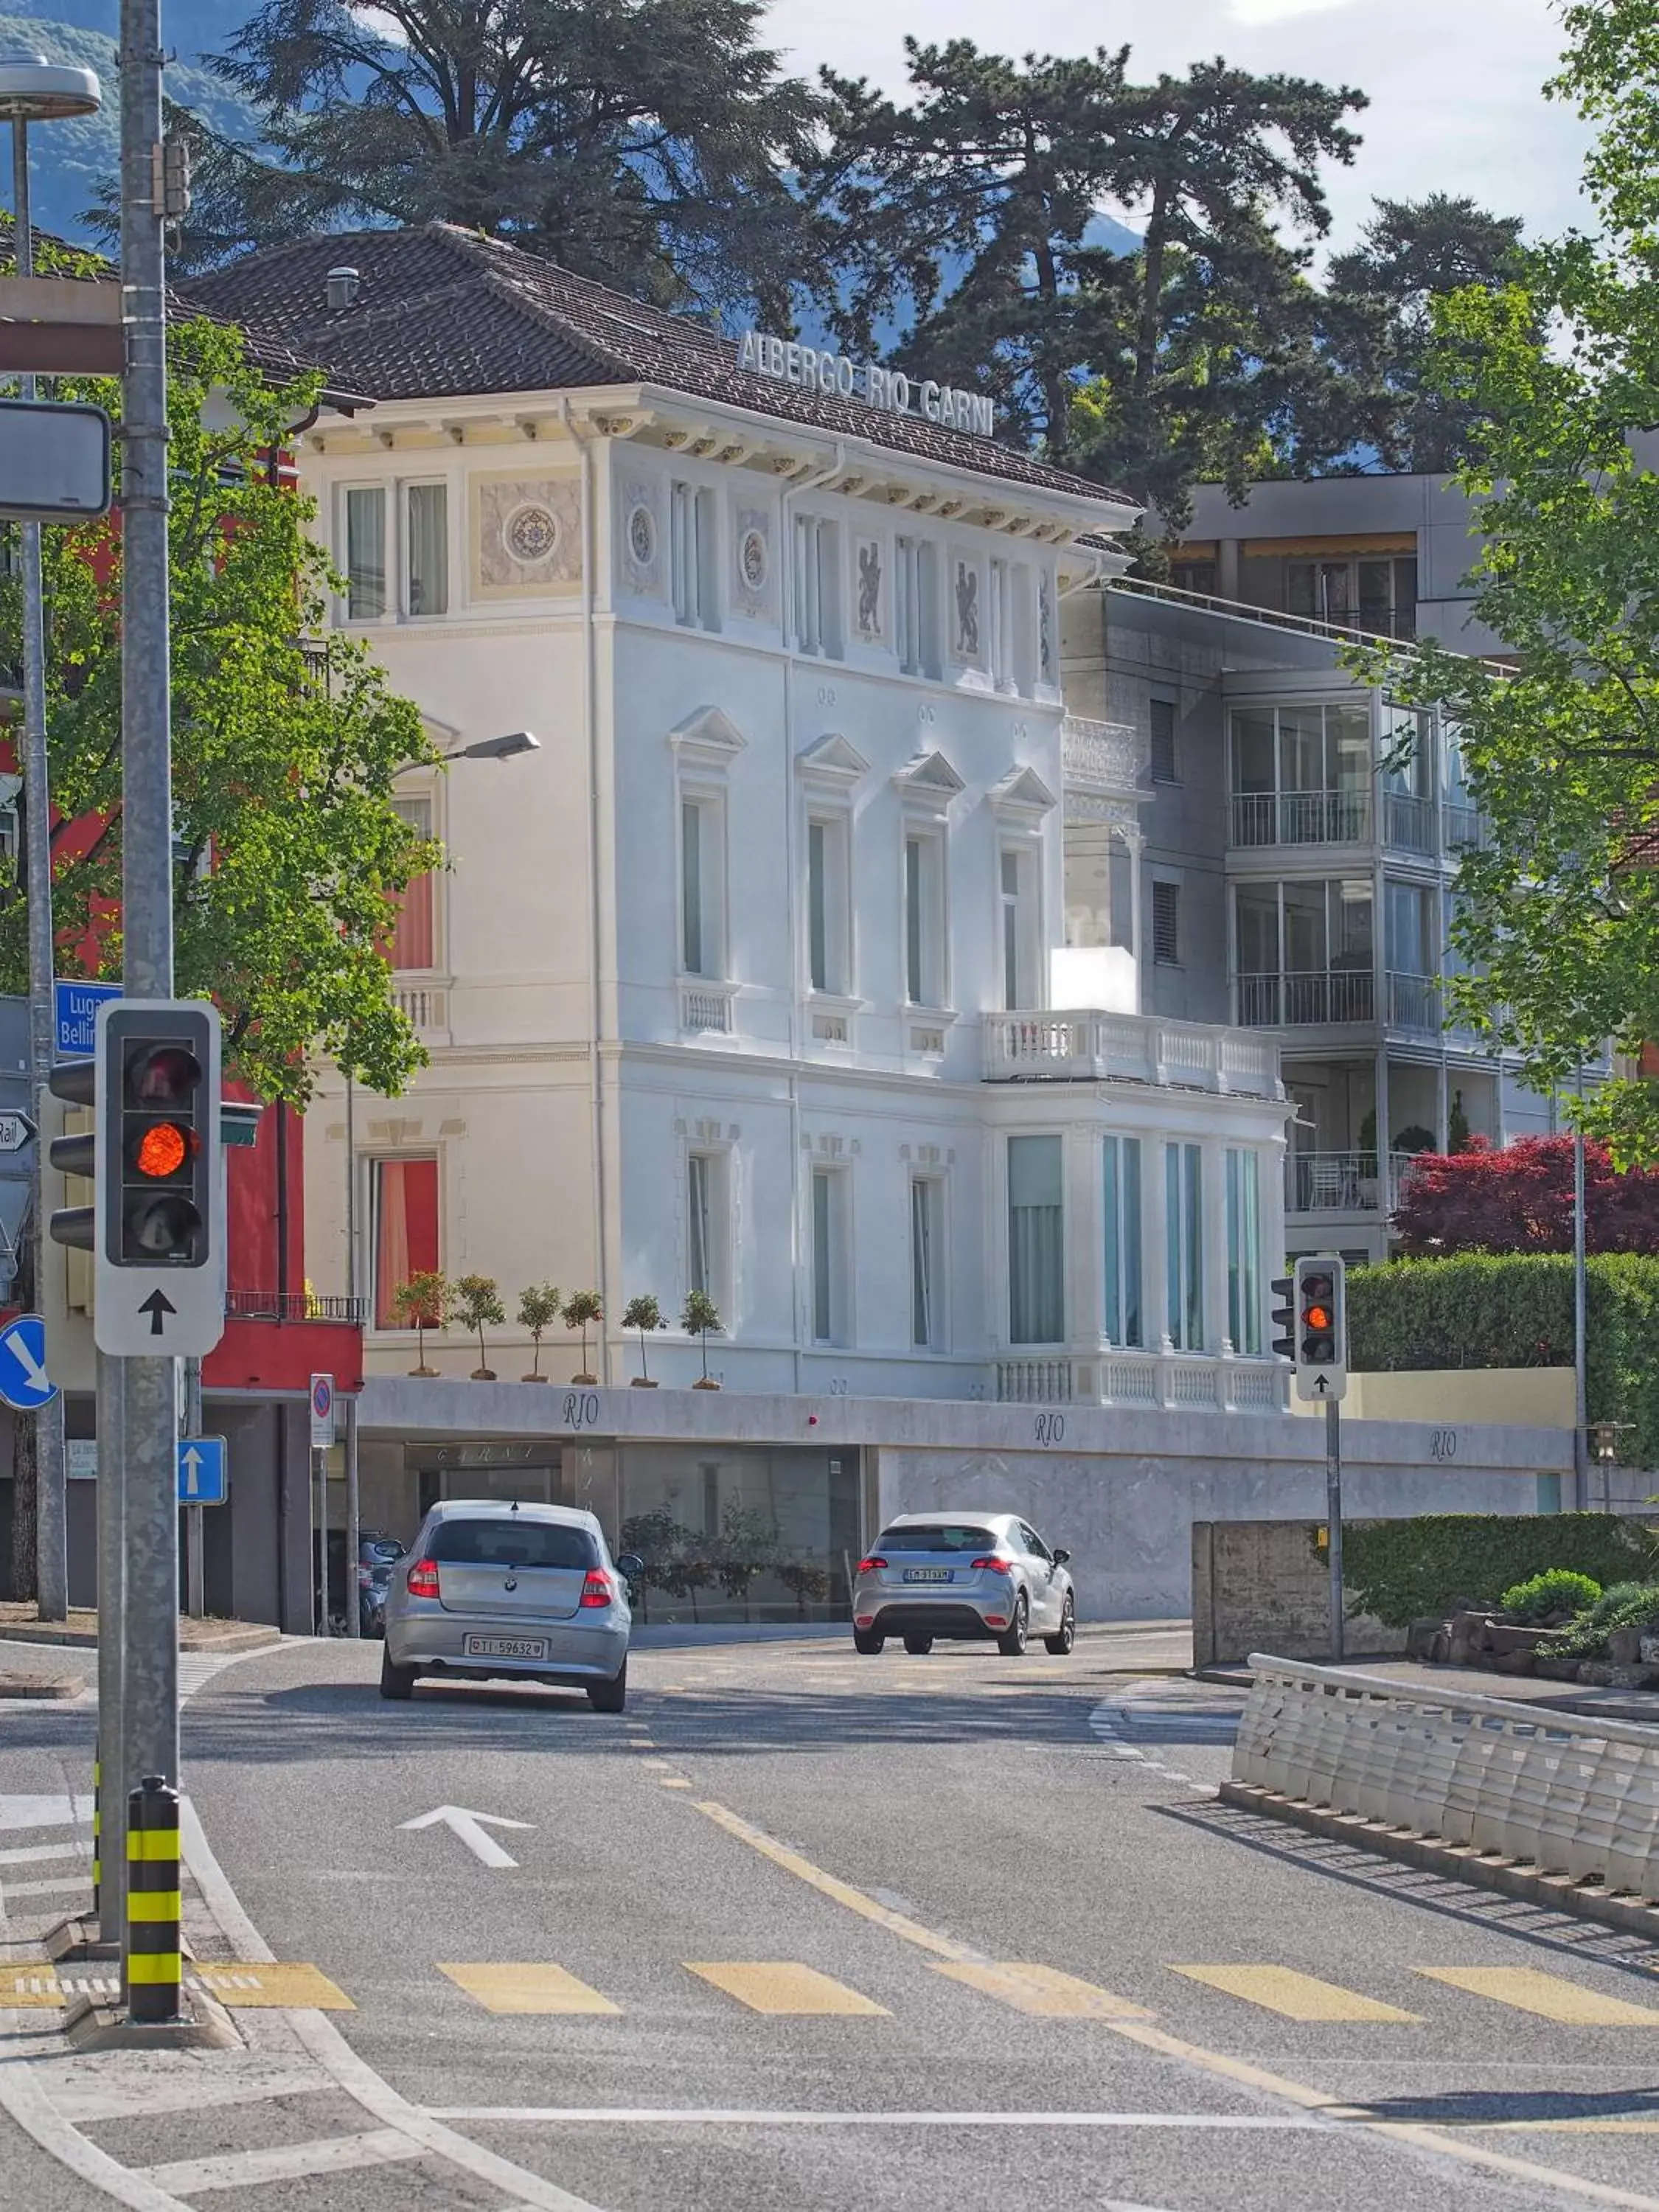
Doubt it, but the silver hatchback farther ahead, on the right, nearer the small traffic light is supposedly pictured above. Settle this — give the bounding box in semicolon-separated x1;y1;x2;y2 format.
852;1513;1077;1659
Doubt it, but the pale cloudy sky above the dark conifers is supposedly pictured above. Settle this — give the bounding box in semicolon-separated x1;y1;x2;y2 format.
765;0;1586;248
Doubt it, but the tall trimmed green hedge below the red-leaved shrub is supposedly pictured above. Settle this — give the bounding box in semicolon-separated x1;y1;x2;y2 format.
1347;1252;1659;1469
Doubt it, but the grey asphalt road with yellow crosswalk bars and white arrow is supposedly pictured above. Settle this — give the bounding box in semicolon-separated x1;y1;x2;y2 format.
0;1635;1659;2212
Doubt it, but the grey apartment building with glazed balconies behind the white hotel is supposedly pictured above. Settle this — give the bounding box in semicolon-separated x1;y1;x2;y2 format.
1066;478;1601;1259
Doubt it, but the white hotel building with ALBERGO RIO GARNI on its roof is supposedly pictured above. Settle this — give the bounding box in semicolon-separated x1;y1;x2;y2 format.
190;226;1287;1411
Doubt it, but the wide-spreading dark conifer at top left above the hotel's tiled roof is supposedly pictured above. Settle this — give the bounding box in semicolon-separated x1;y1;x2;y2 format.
201;0;821;316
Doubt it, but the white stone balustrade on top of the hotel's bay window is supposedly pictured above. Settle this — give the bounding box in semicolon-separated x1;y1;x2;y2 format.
984;1011;1283;1099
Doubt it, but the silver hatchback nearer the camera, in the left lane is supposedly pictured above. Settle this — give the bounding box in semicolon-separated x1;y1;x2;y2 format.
380;1498;644;1712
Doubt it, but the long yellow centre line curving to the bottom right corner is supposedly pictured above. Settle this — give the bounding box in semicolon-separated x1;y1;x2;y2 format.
695;1798;1659;2212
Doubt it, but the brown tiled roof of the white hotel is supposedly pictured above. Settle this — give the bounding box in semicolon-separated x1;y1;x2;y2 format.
186;223;1128;504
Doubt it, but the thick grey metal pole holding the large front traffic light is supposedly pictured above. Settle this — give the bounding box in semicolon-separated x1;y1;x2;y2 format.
122;0;179;1814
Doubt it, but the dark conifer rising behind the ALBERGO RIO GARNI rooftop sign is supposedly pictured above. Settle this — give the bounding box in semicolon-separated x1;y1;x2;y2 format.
803;40;1365;522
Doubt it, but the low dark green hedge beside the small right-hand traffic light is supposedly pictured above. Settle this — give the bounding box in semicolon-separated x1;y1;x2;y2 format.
1343;1522;1659;1628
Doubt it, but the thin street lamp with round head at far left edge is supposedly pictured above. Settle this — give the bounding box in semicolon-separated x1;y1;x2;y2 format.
0;43;100;1621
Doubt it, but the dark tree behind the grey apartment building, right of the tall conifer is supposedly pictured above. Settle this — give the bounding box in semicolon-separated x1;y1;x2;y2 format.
1303;192;1522;473
